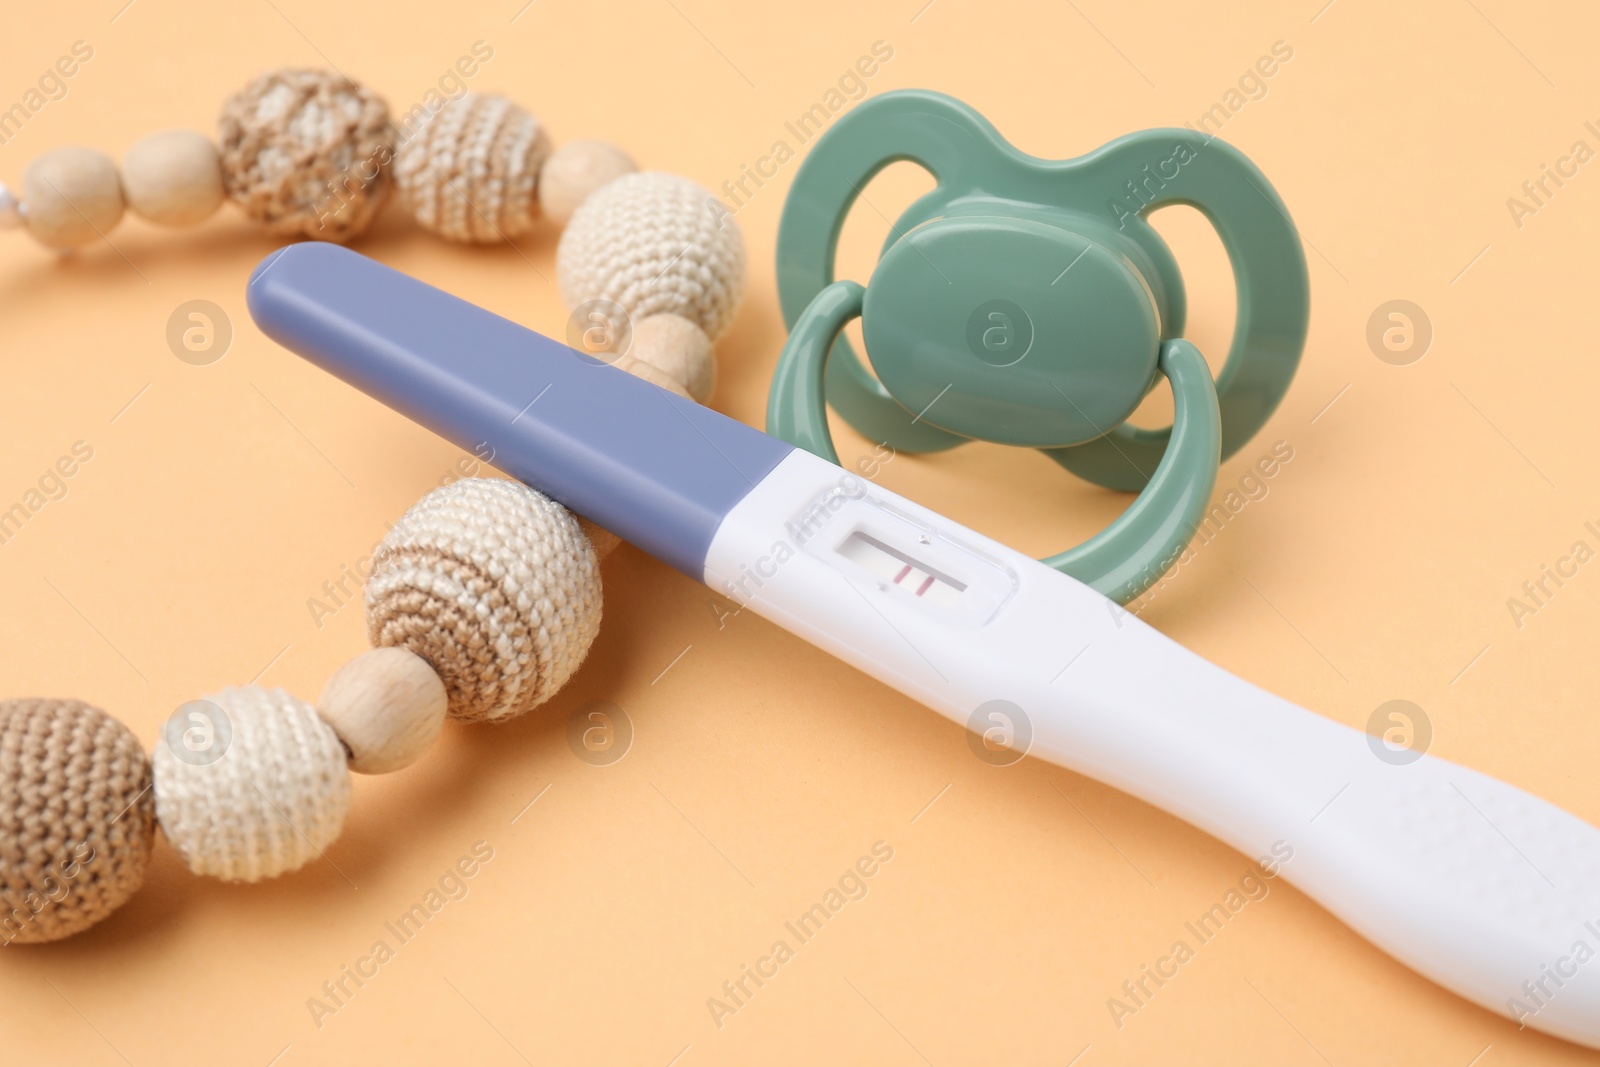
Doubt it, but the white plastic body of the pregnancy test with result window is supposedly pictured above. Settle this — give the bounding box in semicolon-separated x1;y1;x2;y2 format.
706;450;1600;1046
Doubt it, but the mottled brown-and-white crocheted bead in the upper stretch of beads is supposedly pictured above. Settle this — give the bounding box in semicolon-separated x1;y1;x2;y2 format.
218;69;394;242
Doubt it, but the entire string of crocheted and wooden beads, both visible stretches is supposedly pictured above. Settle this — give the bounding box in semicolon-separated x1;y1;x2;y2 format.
0;69;744;945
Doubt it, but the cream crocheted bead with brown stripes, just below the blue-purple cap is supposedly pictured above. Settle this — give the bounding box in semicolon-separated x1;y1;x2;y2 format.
366;478;600;721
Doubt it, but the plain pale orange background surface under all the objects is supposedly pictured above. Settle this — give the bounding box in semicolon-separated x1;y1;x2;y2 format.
0;0;1600;1067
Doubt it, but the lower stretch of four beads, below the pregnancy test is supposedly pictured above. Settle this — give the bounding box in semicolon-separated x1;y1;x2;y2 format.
0;478;602;944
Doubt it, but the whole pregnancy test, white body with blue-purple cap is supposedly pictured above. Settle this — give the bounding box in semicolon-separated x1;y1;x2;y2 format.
248;242;1600;1048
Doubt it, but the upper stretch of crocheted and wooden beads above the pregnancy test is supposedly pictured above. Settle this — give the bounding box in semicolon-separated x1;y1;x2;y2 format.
0;63;744;403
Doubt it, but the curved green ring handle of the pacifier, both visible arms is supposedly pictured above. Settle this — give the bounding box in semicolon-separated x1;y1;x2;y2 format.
766;280;1222;603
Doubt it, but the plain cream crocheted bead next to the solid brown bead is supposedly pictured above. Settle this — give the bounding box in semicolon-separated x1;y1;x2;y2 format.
152;685;350;881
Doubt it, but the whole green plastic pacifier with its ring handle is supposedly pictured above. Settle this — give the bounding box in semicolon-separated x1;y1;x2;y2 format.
766;90;1310;603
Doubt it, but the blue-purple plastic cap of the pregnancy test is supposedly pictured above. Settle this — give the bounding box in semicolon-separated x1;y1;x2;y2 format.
246;242;792;581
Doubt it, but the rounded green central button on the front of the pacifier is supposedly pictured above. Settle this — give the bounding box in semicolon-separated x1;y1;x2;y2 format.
861;216;1160;448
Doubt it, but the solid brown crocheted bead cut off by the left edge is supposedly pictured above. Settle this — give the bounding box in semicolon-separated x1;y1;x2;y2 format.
0;699;155;942
